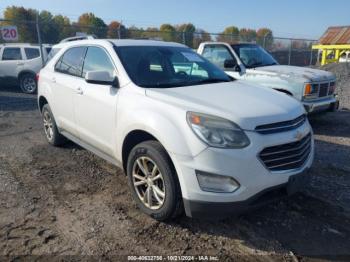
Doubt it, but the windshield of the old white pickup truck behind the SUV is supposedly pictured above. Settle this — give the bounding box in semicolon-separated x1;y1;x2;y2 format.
232;44;278;68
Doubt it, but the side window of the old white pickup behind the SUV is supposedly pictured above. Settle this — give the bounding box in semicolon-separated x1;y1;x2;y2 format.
203;45;237;69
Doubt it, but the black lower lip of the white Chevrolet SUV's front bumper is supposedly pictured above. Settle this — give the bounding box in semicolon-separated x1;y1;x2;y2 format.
183;170;308;219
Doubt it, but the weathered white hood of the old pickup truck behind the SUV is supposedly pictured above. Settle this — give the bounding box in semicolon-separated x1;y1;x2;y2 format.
249;65;335;83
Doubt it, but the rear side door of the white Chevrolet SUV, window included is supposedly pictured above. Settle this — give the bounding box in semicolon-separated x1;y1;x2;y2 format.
48;47;86;137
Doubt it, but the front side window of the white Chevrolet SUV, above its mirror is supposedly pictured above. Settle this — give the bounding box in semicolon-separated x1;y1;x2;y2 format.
83;47;115;77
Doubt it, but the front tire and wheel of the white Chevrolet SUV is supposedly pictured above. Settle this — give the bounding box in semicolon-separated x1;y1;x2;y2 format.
127;141;183;221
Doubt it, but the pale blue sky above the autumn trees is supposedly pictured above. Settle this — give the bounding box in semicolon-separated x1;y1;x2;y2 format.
0;0;350;39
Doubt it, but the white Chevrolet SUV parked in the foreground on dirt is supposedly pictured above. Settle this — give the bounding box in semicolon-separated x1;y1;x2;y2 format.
38;40;314;220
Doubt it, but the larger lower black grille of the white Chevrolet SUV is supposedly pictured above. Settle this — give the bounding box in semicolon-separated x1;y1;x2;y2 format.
259;134;311;171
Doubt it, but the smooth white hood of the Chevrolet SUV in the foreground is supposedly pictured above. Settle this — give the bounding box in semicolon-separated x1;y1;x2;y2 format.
146;81;305;130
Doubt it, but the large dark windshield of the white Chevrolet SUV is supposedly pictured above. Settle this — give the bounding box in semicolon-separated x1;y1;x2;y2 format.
115;46;232;88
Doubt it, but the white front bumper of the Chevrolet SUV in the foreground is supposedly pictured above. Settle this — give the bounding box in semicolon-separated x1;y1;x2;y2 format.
169;121;314;217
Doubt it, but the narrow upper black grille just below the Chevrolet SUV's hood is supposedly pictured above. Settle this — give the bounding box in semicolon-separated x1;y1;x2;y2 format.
255;115;306;134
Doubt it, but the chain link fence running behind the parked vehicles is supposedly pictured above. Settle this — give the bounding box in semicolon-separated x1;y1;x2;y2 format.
0;17;317;66
